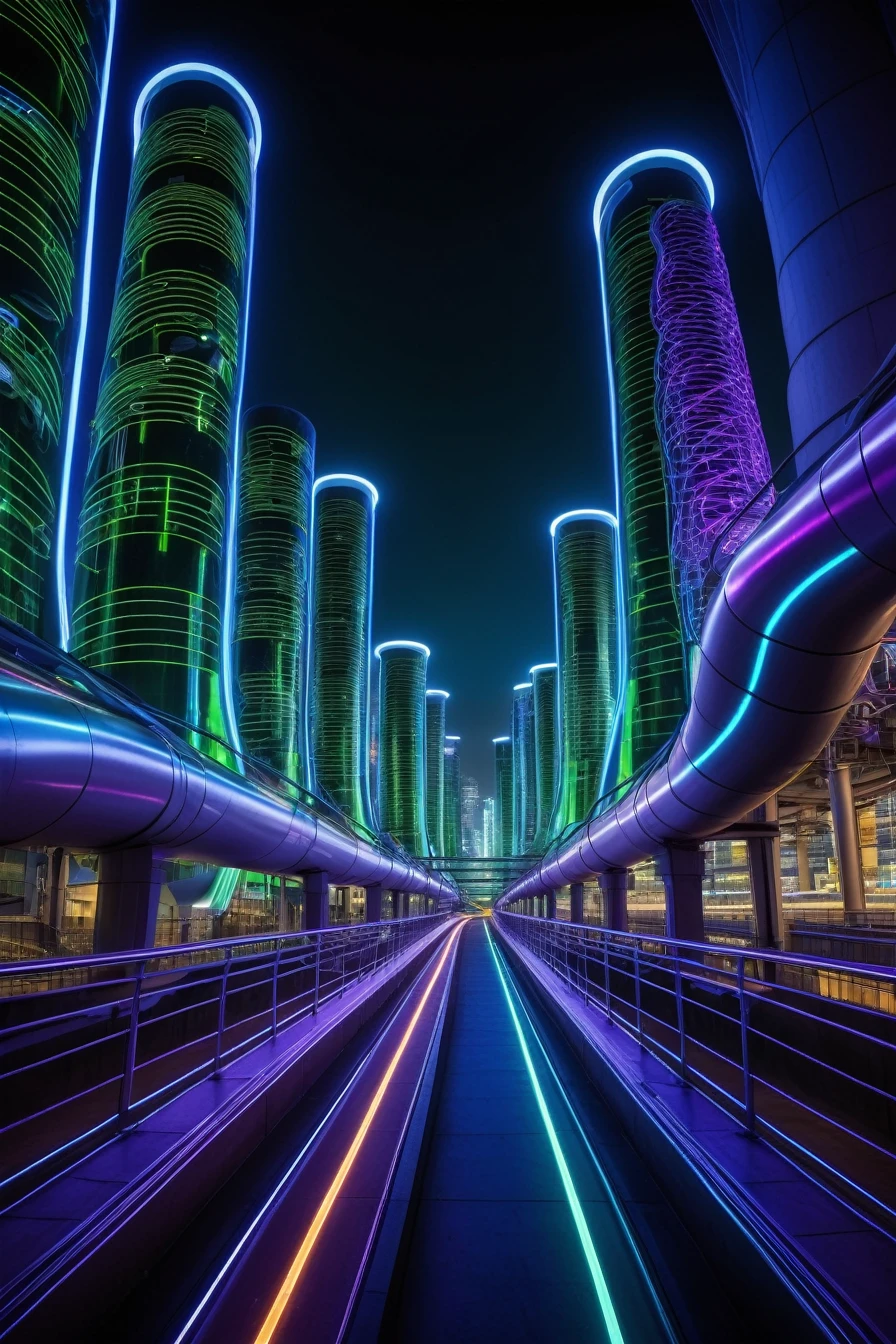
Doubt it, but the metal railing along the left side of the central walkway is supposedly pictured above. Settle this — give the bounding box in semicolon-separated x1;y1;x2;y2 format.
0;914;449;1206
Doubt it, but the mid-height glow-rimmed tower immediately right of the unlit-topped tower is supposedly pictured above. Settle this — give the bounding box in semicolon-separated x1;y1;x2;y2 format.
308;476;382;831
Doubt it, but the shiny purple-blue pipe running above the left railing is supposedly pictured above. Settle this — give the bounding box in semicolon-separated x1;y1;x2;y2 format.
0;656;457;899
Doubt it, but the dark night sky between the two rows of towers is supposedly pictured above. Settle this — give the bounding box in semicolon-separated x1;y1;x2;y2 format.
87;0;790;793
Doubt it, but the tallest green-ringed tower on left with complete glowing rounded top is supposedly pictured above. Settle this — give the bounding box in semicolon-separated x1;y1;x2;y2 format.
71;66;261;750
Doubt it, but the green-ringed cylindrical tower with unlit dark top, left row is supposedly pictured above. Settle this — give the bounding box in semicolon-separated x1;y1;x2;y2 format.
234;406;314;785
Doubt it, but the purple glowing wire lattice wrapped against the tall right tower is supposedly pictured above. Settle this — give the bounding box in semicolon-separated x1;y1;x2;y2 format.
650;200;775;644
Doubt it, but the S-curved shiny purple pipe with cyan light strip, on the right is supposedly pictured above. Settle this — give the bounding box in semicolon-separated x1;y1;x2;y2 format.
498;399;896;905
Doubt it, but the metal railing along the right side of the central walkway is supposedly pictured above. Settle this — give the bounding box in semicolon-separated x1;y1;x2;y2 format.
496;910;896;1231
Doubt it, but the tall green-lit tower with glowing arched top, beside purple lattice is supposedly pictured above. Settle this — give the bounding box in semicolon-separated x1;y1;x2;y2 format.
594;151;711;780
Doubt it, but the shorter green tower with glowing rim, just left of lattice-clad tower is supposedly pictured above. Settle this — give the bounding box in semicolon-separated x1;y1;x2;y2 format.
551;509;618;839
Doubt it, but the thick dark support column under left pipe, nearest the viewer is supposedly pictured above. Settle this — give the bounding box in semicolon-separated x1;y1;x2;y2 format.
93;845;165;952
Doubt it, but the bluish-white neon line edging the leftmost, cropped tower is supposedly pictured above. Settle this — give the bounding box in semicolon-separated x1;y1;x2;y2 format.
55;0;117;650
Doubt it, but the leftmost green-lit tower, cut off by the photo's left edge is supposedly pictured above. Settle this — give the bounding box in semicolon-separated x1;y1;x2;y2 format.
0;0;116;642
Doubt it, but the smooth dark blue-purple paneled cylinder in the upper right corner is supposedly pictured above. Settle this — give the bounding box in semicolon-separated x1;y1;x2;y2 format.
695;0;896;472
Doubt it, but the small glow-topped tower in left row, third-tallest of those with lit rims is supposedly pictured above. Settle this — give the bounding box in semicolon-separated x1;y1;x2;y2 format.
373;640;431;855
